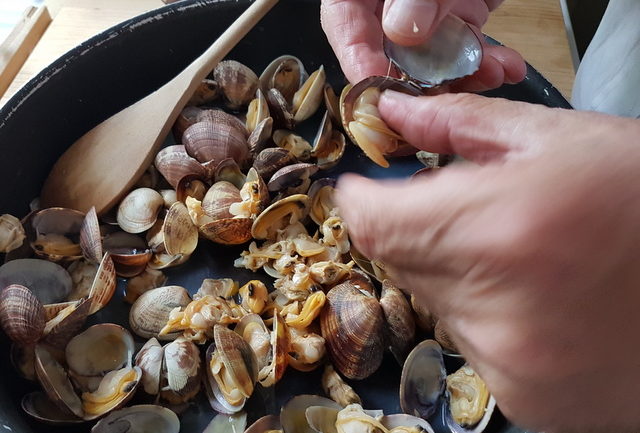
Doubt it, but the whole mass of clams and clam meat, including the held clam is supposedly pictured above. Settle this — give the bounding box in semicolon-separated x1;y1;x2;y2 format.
0;13;495;433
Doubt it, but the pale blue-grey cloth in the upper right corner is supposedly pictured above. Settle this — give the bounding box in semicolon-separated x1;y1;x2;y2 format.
571;0;640;117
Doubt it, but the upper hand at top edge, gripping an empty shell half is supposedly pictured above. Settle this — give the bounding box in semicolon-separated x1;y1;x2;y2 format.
321;0;526;91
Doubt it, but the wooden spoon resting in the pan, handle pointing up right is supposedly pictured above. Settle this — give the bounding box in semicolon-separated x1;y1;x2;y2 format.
40;0;278;214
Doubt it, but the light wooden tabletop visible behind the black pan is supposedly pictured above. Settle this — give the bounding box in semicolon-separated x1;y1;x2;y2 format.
0;0;575;106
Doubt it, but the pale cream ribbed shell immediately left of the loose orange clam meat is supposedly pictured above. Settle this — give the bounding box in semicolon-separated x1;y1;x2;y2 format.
129;286;191;340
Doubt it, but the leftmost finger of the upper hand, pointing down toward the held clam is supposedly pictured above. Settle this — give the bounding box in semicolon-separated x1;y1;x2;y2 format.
320;0;389;83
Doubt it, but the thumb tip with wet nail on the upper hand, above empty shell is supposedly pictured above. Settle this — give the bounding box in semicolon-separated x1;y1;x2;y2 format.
382;0;438;43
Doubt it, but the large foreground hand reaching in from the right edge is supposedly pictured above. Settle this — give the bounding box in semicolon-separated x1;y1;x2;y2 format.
336;92;640;433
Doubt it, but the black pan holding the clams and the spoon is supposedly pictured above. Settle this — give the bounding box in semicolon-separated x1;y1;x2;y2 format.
0;0;570;433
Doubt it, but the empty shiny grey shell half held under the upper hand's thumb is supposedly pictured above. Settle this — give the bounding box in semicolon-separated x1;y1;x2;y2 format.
384;15;482;88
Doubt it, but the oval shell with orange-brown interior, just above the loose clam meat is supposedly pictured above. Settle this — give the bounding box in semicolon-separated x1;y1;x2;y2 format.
251;194;309;239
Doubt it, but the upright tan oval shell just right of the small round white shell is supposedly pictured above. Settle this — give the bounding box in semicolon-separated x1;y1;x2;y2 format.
162;202;198;255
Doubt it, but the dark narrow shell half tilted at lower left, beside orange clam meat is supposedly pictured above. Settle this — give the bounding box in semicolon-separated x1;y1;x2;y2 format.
35;344;84;418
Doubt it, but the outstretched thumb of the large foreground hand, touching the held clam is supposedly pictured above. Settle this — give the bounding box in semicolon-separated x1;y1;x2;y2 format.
378;91;556;163
